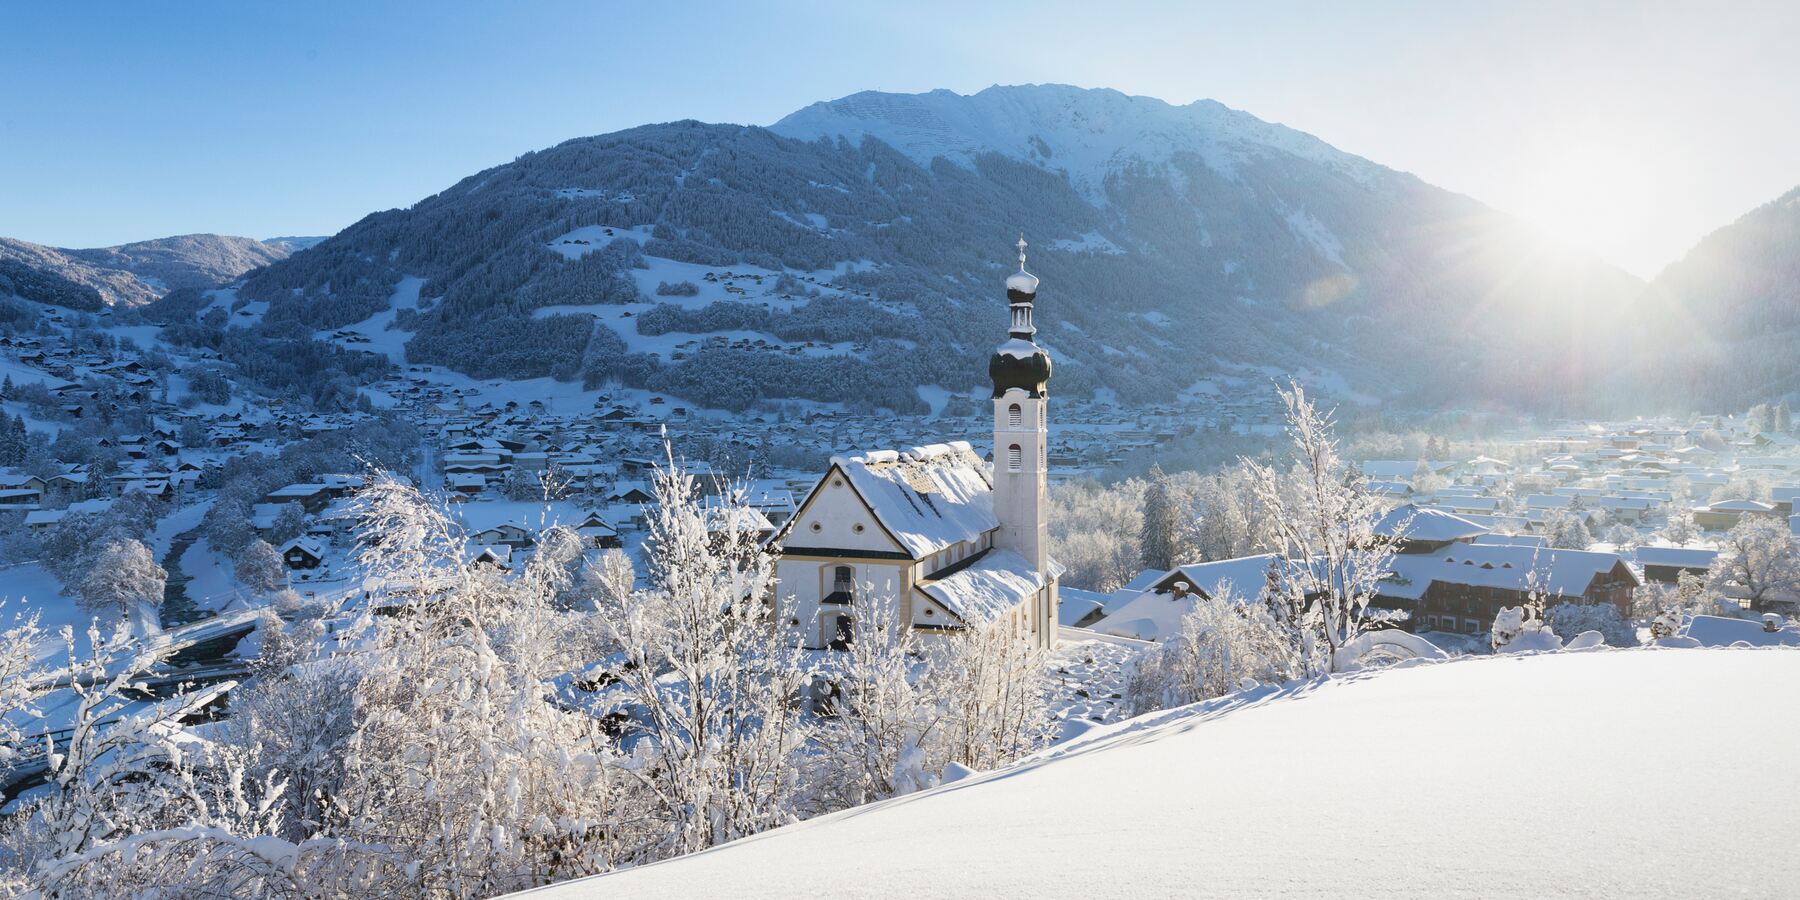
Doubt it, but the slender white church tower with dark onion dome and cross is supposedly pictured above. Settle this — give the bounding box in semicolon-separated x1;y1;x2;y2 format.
988;236;1055;576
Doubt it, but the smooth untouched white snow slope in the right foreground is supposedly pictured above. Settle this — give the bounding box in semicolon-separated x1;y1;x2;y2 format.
520;650;1800;900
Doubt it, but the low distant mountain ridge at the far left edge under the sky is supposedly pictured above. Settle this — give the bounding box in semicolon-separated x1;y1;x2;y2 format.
0;234;297;306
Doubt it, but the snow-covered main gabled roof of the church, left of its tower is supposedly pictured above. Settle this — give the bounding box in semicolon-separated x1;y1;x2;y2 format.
832;441;999;560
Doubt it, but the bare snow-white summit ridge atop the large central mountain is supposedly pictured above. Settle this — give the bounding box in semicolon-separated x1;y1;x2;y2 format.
769;85;1386;198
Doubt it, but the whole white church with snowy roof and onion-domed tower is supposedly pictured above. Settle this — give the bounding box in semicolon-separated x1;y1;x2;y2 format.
770;238;1062;650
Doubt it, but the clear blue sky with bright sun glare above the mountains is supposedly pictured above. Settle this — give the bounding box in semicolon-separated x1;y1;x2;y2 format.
0;0;1800;275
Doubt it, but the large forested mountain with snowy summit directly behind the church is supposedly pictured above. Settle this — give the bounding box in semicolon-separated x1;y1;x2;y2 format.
228;85;1642;409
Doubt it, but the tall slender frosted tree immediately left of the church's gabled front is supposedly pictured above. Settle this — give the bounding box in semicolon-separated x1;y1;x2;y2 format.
596;450;812;855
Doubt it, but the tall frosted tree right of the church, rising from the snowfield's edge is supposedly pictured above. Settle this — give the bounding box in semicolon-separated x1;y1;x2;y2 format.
1244;382;1395;671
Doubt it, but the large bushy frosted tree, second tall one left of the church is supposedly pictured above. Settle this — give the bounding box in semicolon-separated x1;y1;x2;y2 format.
322;475;639;896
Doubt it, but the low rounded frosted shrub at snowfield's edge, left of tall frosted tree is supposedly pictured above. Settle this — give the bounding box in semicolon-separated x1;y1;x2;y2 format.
1125;596;1305;715
